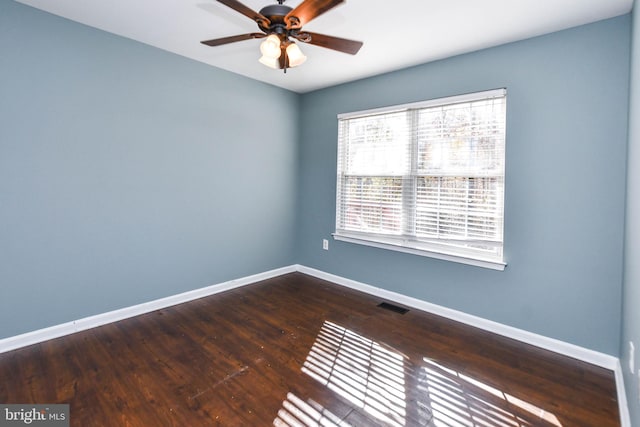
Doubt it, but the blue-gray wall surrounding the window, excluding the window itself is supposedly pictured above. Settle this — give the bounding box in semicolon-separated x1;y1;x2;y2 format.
297;15;630;355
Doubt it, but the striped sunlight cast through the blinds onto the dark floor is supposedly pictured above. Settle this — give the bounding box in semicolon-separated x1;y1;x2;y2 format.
273;321;562;427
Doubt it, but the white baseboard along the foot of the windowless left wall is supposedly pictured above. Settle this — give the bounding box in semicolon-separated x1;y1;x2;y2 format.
0;265;296;353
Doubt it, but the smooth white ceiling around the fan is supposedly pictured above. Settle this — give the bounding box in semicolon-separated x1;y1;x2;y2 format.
17;0;633;93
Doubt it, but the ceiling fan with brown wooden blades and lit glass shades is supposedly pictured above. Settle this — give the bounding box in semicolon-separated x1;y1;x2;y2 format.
200;0;362;73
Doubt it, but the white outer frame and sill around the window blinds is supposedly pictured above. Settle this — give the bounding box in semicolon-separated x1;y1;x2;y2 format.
332;88;507;271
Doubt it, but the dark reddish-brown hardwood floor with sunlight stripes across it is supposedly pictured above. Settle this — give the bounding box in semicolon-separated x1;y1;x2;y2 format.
0;273;620;427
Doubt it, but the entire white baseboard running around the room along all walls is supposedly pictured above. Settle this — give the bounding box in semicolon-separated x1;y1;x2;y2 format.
0;264;631;427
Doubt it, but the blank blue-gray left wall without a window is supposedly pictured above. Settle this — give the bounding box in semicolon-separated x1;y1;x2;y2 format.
0;1;300;338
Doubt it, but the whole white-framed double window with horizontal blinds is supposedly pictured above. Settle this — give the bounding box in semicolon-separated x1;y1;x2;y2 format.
334;89;506;270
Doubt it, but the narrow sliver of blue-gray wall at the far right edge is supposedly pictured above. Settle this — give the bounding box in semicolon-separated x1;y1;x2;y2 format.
620;1;640;426
